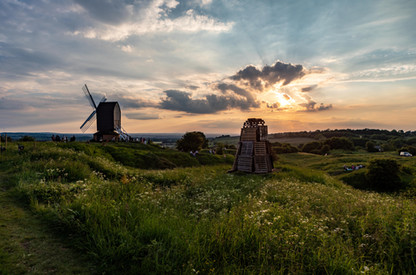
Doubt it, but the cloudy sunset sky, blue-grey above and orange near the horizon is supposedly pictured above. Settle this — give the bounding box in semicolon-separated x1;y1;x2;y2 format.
0;0;416;134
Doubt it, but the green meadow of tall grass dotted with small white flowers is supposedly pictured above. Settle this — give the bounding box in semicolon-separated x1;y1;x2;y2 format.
0;142;416;274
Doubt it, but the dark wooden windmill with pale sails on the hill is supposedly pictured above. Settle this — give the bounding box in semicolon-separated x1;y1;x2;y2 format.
80;84;130;141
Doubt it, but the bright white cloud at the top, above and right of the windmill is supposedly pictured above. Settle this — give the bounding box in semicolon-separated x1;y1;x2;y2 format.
70;0;233;41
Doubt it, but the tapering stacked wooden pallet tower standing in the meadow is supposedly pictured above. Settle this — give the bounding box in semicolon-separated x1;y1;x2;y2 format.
232;118;273;173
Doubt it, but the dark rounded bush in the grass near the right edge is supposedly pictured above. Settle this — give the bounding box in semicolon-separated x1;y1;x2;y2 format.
366;159;402;191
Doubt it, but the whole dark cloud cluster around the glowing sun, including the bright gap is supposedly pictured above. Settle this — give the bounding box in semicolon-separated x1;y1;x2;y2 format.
151;62;332;114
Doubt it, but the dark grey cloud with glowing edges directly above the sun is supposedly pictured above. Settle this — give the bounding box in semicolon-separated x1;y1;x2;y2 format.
230;62;306;90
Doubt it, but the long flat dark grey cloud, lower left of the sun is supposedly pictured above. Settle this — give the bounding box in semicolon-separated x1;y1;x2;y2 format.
159;90;258;114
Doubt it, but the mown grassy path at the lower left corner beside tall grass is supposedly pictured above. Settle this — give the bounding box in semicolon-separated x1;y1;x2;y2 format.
0;177;96;274
